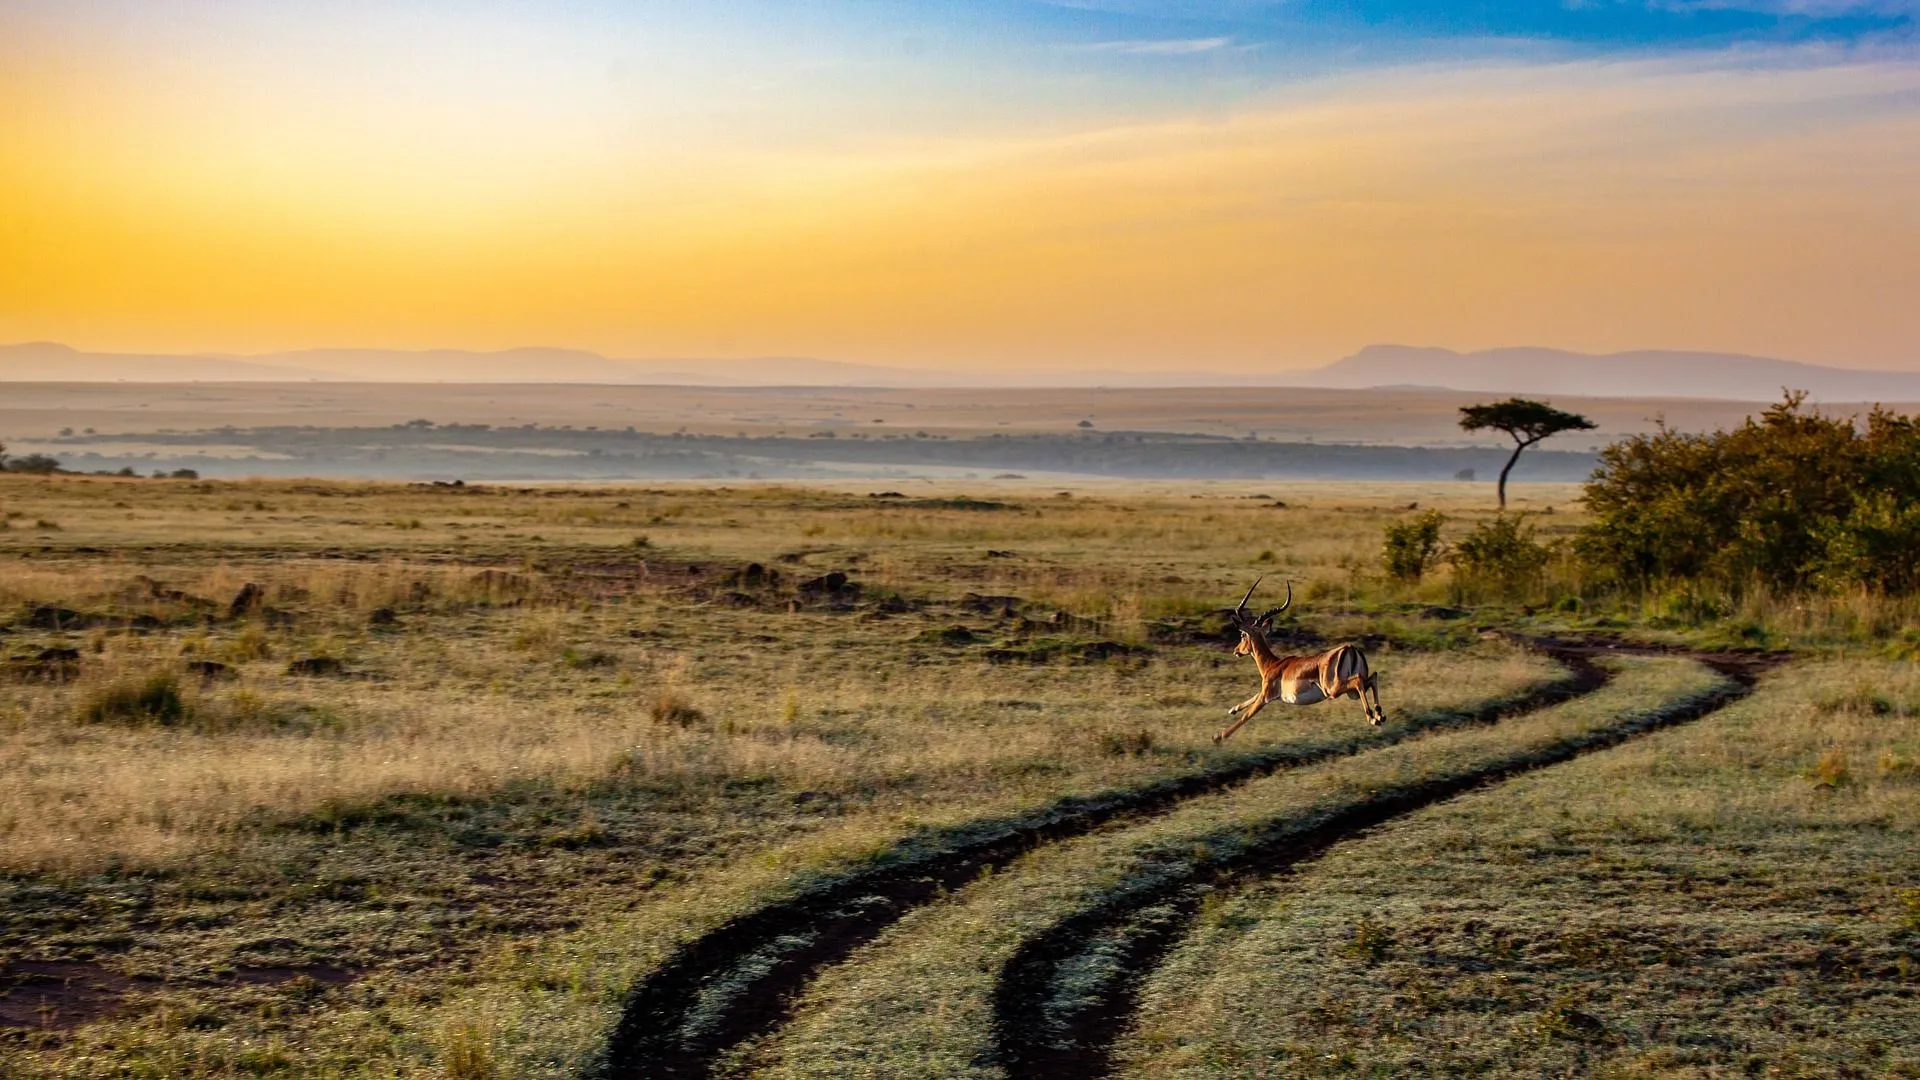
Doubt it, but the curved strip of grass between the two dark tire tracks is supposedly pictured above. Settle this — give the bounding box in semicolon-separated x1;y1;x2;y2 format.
741;661;1715;1078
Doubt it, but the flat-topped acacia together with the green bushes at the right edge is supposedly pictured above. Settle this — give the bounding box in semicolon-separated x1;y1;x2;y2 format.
1405;392;1920;596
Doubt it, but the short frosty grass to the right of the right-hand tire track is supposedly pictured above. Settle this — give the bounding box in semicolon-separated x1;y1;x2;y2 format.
1127;661;1920;1078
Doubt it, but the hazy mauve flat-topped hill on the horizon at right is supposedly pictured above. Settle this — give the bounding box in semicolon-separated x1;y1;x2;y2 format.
1292;346;1920;402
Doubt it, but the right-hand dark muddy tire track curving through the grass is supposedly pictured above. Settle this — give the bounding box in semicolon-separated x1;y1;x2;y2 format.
991;640;1784;1080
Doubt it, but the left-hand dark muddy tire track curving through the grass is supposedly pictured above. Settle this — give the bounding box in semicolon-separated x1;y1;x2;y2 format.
589;642;1611;1080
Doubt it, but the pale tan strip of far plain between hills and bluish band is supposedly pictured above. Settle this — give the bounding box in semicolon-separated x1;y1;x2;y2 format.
0;382;1804;445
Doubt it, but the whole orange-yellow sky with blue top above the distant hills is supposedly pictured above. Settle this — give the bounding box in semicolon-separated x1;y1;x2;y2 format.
0;0;1920;371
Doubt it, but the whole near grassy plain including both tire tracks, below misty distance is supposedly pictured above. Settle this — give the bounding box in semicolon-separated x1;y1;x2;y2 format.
0;477;1920;1078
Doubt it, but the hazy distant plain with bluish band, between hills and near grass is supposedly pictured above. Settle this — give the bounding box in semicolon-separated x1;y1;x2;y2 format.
0;382;1864;482
